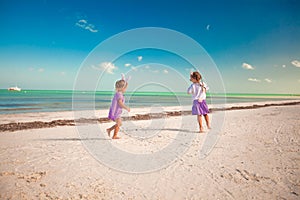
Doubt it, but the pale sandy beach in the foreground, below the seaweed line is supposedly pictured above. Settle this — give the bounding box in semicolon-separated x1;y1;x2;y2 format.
0;104;300;199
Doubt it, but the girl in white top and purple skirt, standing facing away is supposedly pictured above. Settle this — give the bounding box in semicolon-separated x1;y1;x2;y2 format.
188;72;210;133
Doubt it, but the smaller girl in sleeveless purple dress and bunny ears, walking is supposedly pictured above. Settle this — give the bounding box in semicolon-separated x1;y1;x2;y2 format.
106;77;130;139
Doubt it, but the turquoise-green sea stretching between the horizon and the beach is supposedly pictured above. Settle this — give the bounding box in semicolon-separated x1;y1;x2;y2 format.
0;89;300;114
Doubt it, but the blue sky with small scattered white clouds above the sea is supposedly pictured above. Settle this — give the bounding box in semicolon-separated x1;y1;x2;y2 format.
0;0;300;94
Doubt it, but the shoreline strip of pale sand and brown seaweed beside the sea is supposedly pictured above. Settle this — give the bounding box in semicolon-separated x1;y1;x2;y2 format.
0;100;300;133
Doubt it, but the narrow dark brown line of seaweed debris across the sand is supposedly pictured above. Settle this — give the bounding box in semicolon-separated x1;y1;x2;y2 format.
0;101;300;132
